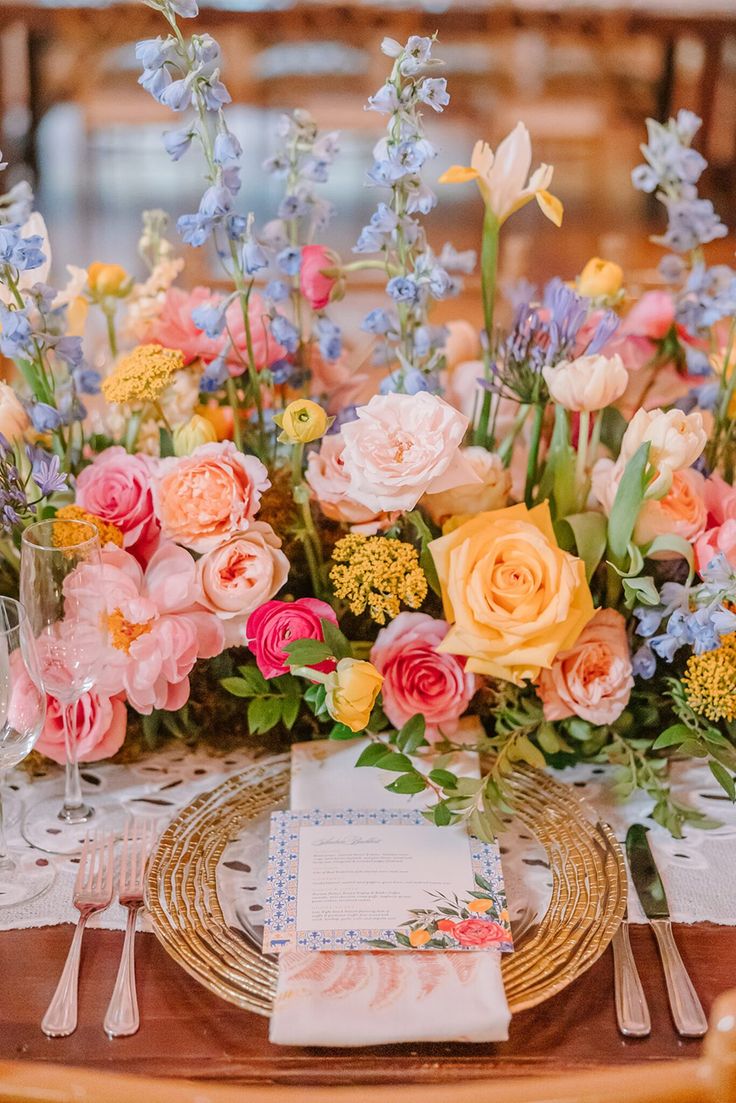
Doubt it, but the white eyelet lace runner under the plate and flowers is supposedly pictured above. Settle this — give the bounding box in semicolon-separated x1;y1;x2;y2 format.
0;745;736;931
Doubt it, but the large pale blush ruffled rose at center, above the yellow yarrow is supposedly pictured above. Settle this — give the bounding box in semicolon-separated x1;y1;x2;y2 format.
342;390;480;512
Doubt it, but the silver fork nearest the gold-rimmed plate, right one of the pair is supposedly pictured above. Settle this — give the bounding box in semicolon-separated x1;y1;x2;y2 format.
104;821;156;1038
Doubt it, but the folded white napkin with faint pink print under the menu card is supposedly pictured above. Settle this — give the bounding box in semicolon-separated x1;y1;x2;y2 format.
269;740;511;1046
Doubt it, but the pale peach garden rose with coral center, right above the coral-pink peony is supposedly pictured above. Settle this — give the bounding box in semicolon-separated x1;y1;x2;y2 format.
196;521;289;646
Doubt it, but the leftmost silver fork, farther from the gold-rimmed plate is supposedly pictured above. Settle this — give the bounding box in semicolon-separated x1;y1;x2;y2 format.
41;832;115;1038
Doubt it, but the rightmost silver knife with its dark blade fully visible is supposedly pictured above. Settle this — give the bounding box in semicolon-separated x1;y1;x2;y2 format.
626;824;707;1038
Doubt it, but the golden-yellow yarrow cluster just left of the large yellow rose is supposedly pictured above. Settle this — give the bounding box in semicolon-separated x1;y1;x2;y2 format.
330;533;427;624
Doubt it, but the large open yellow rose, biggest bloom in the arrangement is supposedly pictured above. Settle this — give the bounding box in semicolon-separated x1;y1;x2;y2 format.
429;502;594;685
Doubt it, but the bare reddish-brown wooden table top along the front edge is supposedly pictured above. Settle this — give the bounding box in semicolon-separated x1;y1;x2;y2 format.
0;924;736;1084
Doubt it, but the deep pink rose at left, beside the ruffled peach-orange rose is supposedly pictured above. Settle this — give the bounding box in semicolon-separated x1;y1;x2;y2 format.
76;446;161;563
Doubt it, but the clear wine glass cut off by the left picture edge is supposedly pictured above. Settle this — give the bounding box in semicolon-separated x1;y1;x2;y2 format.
0;598;55;908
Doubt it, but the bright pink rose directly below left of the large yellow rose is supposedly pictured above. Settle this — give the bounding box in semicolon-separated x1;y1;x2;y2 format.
371;613;478;742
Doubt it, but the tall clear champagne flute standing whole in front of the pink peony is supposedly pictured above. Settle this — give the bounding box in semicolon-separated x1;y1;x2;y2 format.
21;518;118;854
